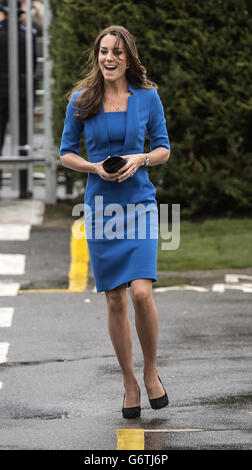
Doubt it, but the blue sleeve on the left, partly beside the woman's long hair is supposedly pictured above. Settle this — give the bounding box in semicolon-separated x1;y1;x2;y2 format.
60;93;84;155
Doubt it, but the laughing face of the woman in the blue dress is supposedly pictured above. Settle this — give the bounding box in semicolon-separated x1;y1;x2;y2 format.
98;34;127;81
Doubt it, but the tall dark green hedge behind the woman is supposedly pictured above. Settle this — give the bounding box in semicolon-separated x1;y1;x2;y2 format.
50;0;252;217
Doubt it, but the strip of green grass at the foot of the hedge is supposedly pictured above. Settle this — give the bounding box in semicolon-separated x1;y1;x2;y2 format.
158;218;252;271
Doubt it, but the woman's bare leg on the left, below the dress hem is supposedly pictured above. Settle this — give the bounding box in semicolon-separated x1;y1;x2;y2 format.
105;285;139;408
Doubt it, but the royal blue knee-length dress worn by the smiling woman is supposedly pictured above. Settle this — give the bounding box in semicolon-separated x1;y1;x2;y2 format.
60;85;170;292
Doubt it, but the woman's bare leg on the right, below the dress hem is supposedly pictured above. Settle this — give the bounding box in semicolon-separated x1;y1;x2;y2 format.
130;279;165;398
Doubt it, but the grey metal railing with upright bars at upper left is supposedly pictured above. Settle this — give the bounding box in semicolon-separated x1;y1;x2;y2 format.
0;0;57;204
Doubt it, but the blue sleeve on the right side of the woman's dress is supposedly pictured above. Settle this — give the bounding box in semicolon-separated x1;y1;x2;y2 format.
147;88;170;150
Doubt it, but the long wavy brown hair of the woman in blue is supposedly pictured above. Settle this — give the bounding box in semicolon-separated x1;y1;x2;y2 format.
68;25;158;121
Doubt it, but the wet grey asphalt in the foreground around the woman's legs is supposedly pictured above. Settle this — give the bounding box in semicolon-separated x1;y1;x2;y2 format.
0;290;252;450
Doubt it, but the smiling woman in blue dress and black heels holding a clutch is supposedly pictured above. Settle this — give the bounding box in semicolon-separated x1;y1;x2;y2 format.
60;26;170;418
